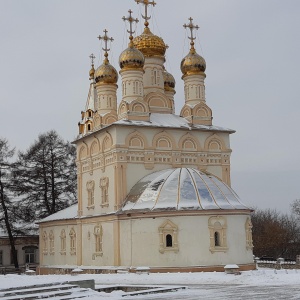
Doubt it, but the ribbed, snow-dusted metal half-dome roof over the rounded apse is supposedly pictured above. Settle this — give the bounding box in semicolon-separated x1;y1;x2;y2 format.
122;168;251;211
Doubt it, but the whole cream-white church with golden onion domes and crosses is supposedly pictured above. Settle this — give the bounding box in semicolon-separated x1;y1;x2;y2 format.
39;0;255;274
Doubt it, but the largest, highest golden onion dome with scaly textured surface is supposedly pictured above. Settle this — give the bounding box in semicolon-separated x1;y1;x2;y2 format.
133;27;167;56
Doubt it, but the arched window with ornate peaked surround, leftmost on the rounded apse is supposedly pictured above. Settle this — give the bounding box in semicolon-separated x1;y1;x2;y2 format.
158;220;179;254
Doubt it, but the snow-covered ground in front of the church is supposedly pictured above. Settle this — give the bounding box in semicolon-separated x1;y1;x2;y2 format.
0;269;300;300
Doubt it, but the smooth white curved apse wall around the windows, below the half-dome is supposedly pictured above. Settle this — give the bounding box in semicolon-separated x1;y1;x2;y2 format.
121;215;253;267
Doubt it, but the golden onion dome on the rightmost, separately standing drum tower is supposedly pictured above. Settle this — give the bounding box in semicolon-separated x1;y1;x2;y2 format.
180;49;206;75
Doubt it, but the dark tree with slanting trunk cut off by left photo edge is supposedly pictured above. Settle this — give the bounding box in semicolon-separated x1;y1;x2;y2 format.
0;138;19;268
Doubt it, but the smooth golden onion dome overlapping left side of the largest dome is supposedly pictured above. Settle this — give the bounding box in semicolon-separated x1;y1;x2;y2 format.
119;45;145;69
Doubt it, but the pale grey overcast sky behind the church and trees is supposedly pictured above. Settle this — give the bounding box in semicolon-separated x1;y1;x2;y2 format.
0;0;300;212
